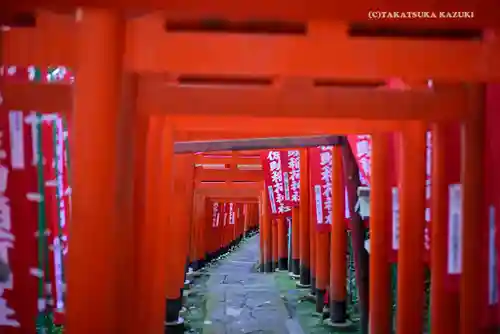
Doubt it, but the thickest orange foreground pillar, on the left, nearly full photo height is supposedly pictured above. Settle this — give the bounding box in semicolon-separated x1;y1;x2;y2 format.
66;8;135;334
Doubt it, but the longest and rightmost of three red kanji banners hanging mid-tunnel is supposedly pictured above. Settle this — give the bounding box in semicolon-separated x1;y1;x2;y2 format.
309;146;333;232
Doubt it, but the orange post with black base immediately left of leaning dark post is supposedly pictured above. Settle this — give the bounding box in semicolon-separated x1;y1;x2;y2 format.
330;145;347;325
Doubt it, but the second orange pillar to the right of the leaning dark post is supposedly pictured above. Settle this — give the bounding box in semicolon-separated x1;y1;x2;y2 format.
396;121;426;334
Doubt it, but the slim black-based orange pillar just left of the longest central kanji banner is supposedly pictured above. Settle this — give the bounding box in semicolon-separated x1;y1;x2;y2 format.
297;149;311;288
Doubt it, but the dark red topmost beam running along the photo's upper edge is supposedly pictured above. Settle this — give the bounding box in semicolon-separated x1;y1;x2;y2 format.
2;0;500;26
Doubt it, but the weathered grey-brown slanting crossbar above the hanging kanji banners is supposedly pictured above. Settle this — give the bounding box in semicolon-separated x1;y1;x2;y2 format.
174;135;342;153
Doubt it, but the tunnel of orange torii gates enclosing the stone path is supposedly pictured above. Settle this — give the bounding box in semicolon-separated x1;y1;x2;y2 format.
0;1;500;334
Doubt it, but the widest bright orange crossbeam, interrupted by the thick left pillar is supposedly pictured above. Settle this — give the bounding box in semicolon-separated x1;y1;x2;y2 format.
3;15;500;82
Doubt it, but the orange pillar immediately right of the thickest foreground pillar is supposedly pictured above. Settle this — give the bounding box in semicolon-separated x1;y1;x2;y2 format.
143;116;173;333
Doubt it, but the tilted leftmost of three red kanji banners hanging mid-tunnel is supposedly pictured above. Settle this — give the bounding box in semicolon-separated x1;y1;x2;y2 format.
261;150;291;216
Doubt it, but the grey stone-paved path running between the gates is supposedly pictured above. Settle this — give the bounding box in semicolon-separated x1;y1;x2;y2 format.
186;235;303;334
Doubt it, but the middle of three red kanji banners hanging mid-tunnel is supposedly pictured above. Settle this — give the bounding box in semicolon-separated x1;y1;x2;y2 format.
281;150;300;206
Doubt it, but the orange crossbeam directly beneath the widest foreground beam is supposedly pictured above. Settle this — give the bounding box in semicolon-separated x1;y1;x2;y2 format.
139;76;470;121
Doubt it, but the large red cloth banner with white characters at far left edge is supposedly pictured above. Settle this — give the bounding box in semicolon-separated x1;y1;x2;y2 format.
0;109;40;334
